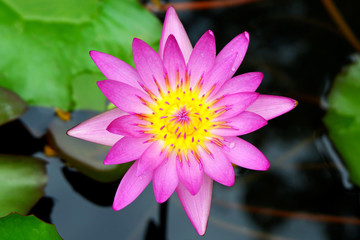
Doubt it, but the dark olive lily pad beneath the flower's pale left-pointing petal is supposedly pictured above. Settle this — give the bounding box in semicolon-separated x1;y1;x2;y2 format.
49;110;131;182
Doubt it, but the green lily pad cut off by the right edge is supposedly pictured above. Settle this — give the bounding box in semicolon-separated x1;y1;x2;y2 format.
324;55;360;186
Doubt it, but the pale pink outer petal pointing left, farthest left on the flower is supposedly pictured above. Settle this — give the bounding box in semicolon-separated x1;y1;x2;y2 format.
67;108;126;146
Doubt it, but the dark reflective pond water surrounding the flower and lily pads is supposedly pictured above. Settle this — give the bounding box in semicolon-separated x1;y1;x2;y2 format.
0;0;360;240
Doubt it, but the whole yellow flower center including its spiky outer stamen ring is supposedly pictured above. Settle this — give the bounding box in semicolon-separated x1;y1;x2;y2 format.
135;73;225;158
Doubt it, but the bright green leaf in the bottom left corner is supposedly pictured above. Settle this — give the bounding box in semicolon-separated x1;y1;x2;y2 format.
0;213;61;240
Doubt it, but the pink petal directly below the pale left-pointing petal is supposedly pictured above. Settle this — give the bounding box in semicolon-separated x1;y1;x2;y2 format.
104;136;150;165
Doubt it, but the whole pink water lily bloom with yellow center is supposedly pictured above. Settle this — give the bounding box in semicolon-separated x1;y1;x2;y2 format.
68;8;296;235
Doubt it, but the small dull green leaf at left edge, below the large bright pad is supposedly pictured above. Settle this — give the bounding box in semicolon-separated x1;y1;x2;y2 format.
0;87;26;125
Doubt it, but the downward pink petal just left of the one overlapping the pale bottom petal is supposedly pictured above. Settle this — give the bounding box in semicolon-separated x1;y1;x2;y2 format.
153;156;179;203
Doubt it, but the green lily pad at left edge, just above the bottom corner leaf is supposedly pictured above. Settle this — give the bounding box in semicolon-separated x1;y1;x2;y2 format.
0;155;48;218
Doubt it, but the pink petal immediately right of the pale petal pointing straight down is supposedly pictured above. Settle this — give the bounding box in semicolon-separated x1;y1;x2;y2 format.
199;143;235;187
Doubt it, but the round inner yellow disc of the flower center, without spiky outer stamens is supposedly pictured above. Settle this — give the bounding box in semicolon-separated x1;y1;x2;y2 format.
149;91;212;152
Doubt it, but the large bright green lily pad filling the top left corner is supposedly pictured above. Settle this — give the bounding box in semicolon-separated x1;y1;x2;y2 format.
0;0;161;111
